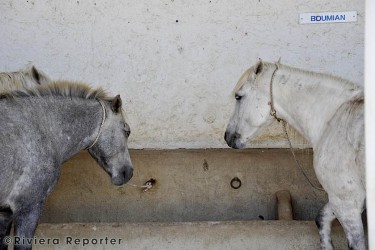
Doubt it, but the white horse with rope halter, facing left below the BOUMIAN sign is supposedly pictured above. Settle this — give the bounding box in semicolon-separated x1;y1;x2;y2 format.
225;61;366;249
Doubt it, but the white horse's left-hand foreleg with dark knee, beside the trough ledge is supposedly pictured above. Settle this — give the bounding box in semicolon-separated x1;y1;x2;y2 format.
315;203;336;250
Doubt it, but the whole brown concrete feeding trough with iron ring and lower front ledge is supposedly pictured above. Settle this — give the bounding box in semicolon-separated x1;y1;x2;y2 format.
35;149;347;249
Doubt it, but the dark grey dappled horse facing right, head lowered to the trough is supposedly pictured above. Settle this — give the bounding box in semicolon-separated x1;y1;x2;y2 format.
0;82;133;249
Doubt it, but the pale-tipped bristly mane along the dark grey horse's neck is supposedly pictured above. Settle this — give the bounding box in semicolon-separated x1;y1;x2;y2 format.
0;81;113;101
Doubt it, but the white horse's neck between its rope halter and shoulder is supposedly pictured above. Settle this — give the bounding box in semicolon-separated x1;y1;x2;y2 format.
273;66;363;147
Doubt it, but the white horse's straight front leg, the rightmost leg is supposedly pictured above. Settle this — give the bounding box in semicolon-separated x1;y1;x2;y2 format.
337;210;366;250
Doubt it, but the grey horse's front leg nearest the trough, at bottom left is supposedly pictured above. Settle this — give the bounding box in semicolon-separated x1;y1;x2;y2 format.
14;203;43;250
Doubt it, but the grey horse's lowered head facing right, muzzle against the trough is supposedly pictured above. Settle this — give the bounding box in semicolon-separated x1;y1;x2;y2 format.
89;96;133;185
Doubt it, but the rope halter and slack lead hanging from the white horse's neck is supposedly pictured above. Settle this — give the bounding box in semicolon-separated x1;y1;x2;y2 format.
269;63;325;191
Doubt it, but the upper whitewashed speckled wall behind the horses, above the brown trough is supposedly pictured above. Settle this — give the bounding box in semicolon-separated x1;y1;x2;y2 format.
0;0;364;149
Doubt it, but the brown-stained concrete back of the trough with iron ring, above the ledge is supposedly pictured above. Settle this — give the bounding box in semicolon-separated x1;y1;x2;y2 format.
41;149;327;223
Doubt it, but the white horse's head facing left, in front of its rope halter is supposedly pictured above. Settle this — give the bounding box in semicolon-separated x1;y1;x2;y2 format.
224;61;272;148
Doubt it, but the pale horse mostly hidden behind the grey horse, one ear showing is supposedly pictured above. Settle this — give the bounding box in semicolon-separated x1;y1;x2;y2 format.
0;66;51;91
